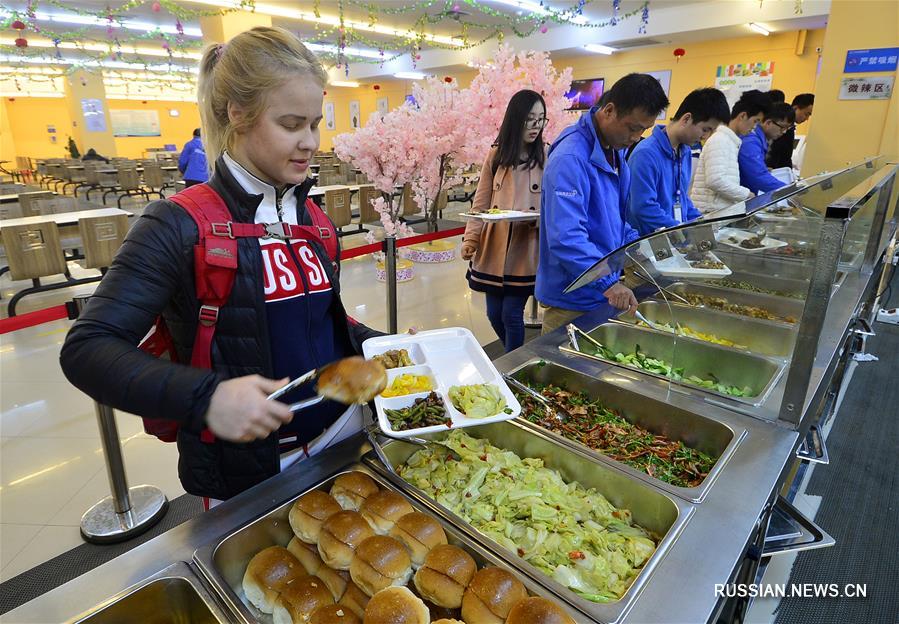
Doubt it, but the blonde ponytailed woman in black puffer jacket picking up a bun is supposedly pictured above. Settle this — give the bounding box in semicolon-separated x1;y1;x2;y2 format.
60;27;374;500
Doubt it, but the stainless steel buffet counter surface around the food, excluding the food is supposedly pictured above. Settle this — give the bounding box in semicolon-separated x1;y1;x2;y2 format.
7;162;894;624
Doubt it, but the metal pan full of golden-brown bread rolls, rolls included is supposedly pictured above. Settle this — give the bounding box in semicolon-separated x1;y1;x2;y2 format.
194;464;583;624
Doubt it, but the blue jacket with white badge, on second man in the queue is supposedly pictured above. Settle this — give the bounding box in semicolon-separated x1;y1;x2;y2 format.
627;126;700;236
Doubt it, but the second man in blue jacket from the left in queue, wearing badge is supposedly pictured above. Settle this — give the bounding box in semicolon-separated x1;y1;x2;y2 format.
627;88;730;236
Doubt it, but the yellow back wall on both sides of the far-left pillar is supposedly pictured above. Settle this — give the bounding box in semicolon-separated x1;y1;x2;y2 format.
0;97;200;160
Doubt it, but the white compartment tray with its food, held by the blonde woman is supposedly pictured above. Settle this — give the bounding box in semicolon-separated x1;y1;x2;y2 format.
362;327;521;437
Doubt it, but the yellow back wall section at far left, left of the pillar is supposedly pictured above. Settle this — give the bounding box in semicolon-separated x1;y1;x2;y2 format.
5;97;74;158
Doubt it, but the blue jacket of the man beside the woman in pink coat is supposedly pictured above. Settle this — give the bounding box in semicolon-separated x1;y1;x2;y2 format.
536;107;638;311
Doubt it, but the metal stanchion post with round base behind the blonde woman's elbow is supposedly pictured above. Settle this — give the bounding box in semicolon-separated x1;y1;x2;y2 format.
66;297;169;544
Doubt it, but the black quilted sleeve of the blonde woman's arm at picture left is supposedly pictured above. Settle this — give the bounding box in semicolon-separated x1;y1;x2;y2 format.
60;201;220;431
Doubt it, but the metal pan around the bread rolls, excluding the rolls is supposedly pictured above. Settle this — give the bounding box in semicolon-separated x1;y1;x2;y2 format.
194;463;580;624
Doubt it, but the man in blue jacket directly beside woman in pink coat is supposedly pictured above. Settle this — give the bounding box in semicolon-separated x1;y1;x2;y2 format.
536;74;668;333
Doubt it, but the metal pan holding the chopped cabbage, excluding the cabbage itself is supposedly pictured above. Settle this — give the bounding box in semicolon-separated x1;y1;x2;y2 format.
362;421;695;624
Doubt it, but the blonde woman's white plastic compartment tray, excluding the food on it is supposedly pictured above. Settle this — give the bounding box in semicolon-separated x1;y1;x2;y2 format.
362;327;521;438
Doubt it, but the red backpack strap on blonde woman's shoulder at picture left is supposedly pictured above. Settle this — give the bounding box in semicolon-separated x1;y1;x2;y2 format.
169;184;237;368
